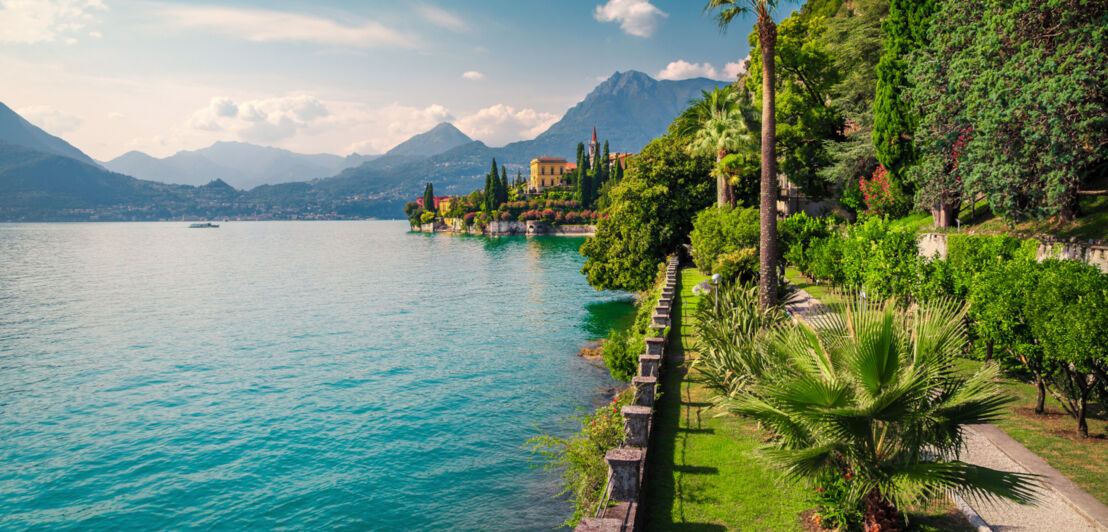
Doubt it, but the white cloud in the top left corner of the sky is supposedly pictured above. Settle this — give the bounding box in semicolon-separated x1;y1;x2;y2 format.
0;0;107;44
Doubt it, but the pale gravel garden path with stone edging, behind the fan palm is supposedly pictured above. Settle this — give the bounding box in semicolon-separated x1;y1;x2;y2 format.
786;290;1108;532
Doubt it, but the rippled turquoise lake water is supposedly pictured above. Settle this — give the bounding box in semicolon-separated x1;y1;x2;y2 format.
0;222;630;530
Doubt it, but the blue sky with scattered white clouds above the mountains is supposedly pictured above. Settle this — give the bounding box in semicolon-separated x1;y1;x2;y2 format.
0;0;780;160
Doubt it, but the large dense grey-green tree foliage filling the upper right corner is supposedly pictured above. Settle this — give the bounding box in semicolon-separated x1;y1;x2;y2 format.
908;0;1108;219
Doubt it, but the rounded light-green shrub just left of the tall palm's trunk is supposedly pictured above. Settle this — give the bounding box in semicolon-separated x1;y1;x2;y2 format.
689;206;761;274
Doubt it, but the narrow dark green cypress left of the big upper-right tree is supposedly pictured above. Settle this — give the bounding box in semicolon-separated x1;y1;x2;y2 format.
873;0;936;192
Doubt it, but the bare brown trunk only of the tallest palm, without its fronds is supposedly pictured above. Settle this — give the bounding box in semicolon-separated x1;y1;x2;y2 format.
758;10;777;308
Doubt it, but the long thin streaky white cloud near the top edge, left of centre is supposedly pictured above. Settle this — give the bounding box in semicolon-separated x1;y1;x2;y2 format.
163;6;416;48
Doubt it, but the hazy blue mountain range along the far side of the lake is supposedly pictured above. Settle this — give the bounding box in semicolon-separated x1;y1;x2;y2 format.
0;71;726;221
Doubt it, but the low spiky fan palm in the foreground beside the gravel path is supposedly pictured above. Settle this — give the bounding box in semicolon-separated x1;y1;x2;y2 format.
724;300;1034;532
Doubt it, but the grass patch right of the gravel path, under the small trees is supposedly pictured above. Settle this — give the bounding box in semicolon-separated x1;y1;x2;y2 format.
958;359;1108;503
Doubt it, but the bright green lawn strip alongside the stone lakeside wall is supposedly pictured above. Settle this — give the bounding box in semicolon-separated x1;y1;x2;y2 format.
643;268;973;532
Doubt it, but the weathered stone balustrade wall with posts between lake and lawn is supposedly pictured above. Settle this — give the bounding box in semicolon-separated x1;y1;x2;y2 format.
575;256;678;532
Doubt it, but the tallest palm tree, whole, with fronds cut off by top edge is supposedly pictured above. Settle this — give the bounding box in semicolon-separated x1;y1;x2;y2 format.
705;0;777;308
